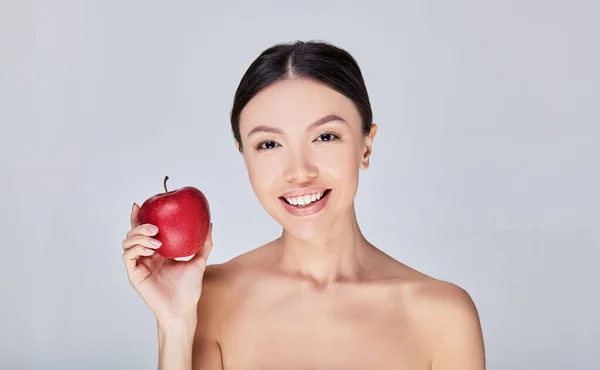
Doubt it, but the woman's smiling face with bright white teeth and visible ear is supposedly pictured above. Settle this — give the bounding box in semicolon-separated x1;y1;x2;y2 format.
240;79;377;240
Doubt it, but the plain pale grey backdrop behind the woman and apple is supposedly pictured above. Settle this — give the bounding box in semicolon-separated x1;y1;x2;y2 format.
0;0;600;370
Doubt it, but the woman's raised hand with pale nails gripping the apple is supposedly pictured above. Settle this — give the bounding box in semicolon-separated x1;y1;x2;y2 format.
122;204;212;325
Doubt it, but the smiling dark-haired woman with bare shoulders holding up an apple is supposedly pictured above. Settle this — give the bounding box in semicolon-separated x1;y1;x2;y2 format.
123;42;485;370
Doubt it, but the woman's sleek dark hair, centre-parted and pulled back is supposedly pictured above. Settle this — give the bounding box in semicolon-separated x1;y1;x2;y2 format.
231;41;373;150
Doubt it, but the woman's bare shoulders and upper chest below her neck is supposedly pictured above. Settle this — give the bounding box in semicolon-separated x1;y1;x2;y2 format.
193;233;484;370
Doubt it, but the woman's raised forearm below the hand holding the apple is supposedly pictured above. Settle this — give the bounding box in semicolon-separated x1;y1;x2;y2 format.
158;320;196;370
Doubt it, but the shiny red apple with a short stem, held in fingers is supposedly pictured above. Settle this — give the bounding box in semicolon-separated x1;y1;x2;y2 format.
139;176;210;258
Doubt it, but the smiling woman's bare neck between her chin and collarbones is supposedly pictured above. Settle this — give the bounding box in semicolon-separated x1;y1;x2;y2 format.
278;206;370;287
